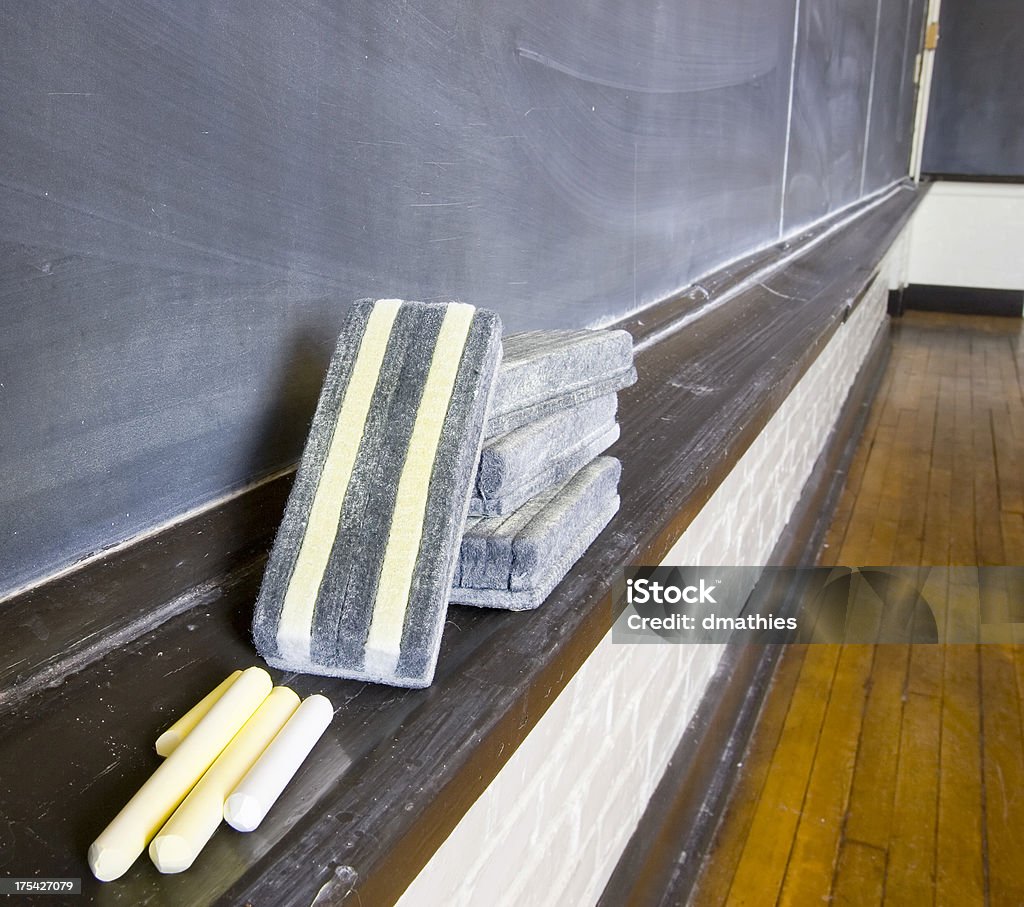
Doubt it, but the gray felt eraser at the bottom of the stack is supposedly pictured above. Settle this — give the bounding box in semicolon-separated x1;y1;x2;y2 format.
451;457;622;611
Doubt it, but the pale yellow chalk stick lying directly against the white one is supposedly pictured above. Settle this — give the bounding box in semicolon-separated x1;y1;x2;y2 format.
150;687;299;872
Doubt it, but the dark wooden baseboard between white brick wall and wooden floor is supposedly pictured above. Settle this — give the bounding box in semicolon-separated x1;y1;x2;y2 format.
598;327;892;907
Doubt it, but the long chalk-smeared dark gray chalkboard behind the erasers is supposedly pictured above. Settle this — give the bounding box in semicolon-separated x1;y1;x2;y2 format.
0;0;920;595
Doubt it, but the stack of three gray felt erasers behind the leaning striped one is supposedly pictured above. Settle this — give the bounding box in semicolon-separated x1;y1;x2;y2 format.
451;331;636;611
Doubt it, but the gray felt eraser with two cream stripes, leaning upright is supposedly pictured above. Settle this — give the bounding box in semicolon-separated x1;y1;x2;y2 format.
253;299;501;687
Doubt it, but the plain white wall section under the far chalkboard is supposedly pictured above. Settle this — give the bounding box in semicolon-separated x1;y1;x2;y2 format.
907;181;1024;290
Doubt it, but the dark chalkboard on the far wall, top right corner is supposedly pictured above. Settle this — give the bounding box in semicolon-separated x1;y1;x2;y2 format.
922;0;1024;179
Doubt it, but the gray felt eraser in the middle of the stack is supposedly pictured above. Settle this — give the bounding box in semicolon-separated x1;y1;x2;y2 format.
469;393;618;516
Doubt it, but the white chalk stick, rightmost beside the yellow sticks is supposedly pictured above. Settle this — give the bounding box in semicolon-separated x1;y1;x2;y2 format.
224;694;334;831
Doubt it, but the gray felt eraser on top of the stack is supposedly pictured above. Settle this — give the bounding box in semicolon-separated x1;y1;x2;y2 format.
485;331;637;438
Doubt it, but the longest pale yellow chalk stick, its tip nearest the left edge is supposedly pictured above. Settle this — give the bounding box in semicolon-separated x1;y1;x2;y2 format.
89;667;272;881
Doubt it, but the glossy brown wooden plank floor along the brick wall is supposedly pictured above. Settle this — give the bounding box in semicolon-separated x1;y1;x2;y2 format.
691;313;1024;907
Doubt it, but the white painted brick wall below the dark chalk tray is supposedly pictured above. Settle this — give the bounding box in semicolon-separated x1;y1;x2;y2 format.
399;267;889;907
